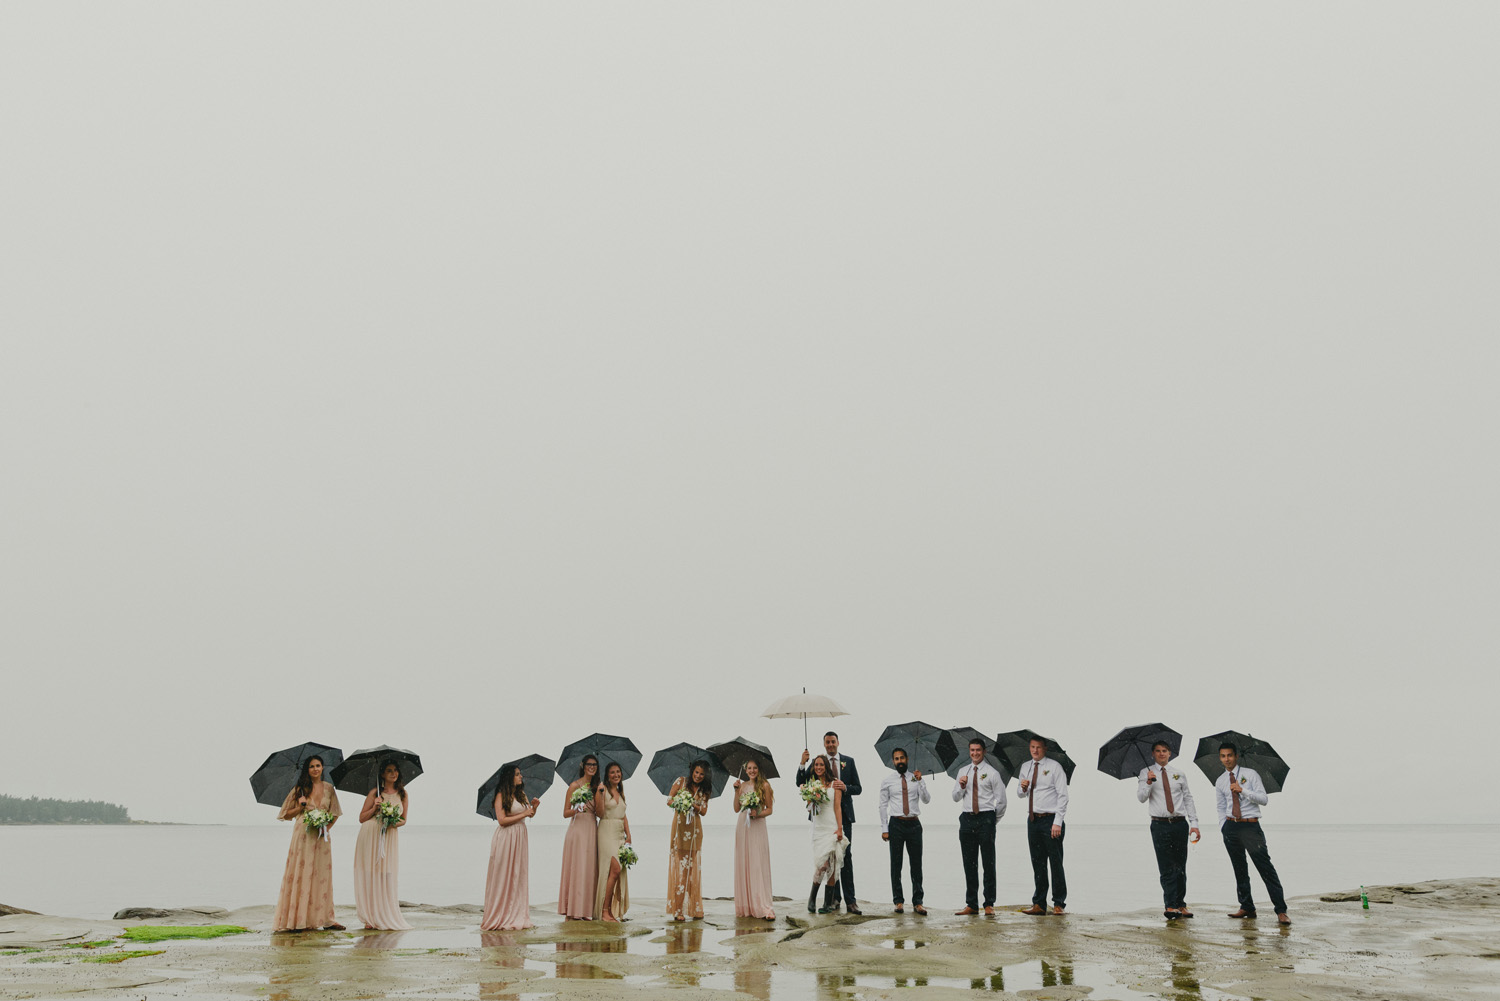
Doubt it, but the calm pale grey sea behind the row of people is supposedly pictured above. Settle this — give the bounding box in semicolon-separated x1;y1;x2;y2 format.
0;821;1500;917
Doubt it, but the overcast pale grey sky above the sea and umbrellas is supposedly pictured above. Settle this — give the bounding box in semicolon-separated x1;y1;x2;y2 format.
0;2;1500;822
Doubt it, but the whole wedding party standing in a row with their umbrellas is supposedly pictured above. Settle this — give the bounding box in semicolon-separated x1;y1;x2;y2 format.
251;695;1290;932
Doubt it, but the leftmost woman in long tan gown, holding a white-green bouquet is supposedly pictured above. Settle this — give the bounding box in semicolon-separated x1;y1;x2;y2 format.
272;755;344;932
